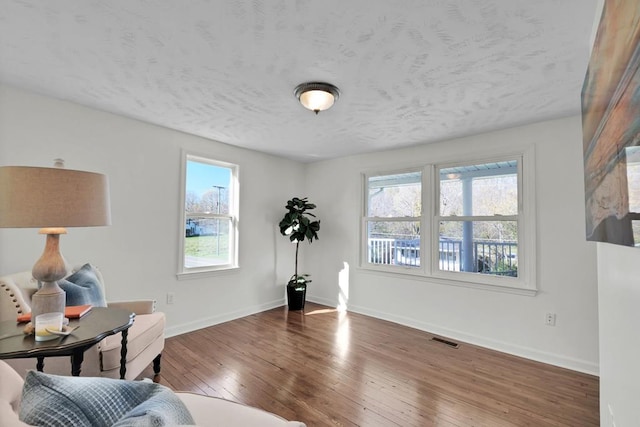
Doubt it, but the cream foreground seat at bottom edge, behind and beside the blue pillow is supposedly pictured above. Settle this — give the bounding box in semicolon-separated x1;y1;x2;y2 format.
0;360;305;427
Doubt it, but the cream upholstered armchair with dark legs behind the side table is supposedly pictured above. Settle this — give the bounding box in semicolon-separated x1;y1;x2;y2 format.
0;266;166;379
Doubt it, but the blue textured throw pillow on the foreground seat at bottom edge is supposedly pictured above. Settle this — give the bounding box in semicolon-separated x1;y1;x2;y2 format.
20;371;195;427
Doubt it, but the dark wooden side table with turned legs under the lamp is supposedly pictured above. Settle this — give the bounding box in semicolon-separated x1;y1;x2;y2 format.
0;307;135;379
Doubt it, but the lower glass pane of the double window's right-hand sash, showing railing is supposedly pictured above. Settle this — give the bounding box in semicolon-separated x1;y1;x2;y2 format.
438;221;518;277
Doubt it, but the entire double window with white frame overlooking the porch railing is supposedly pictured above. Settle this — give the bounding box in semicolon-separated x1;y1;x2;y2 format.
361;153;535;294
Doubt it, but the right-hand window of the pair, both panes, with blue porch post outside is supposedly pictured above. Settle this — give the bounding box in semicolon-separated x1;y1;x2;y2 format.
435;160;518;277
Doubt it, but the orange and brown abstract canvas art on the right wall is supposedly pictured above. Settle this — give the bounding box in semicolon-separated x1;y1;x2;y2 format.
582;0;640;246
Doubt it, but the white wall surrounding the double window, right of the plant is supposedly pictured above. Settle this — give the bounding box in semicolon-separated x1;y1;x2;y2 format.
303;117;598;374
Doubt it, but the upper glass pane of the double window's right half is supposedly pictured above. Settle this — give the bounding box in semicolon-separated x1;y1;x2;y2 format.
440;160;518;216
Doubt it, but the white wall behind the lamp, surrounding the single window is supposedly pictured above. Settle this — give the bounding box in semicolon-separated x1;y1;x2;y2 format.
0;86;304;335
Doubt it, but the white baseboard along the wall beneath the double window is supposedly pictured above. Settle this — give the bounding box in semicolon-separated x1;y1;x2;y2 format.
307;295;599;376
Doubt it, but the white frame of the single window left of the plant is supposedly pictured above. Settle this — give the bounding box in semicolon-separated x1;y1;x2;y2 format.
177;151;240;279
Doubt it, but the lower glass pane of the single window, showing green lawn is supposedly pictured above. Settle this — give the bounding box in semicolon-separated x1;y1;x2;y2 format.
184;217;231;268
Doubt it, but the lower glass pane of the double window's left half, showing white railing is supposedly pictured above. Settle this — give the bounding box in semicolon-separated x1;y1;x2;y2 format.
367;221;420;267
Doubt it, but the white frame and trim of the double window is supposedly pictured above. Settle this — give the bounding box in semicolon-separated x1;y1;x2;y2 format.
360;147;537;296
